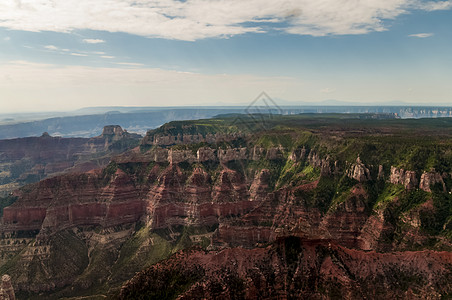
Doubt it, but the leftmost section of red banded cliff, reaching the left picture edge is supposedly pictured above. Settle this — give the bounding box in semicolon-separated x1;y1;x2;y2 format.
2;170;144;235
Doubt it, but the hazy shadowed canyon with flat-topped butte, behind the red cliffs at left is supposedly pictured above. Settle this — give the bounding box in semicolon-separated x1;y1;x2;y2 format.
0;125;141;195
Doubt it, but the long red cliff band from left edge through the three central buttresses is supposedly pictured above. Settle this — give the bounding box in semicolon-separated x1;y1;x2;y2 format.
1;164;268;239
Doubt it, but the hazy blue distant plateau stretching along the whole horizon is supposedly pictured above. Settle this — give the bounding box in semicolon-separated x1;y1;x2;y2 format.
0;105;452;139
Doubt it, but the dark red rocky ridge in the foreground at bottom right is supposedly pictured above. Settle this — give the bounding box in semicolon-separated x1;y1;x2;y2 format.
119;237;452;299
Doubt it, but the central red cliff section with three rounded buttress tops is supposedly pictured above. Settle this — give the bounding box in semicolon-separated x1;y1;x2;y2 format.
145;165;256;228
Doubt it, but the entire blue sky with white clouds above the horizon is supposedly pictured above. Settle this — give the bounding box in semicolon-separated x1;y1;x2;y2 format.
0;0;452;112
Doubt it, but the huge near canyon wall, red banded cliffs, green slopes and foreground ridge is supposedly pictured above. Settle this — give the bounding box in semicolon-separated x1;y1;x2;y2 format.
0;116;452;299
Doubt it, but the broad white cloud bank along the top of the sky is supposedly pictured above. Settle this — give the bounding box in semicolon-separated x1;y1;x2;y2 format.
0;0;452;43
